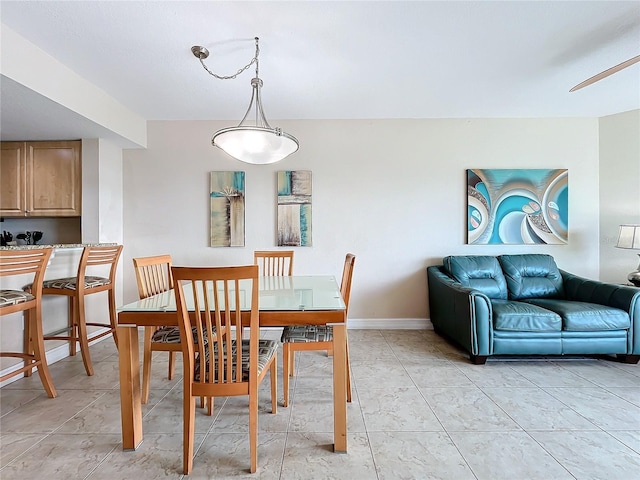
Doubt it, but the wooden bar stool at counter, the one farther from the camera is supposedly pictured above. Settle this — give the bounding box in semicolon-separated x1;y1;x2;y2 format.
37;245;122;376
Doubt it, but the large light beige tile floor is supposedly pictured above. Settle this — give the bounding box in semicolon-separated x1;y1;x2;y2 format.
0;330;640;480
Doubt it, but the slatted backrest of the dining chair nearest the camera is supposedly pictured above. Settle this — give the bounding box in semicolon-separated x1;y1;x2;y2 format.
172;265;260;396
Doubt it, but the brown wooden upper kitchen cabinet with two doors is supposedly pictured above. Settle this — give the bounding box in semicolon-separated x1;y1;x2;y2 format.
0;140;82;217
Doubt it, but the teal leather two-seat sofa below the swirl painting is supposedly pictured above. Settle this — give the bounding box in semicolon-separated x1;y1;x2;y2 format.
427;254;640;364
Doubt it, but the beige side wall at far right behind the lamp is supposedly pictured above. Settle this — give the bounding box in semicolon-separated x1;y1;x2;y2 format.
599;110;640;283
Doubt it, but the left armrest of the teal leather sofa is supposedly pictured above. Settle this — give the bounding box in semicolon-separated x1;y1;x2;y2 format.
427;266;493;356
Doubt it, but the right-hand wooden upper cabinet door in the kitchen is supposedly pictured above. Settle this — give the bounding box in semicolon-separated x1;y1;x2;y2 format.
26;141;82;217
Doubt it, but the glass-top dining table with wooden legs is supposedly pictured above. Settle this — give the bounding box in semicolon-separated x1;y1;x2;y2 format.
117;275;347;453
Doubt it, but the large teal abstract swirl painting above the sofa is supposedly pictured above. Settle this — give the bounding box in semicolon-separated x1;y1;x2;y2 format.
467;169;569;245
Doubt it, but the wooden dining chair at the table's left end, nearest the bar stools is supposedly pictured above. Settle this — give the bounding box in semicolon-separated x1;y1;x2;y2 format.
133;255;176;404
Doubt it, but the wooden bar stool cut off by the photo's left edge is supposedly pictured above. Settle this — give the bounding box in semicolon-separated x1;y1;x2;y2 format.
0;248;58;398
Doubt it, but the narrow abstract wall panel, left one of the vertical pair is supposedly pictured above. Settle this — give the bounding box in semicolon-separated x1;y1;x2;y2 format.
209;172;244;247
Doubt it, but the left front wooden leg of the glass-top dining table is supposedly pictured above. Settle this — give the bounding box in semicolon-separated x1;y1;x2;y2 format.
117;325;142;450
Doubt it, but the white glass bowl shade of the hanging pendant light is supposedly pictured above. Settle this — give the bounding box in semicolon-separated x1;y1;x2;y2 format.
211;126;298;165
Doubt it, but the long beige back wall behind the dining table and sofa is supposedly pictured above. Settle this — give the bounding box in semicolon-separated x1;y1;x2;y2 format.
123;118;600;319
